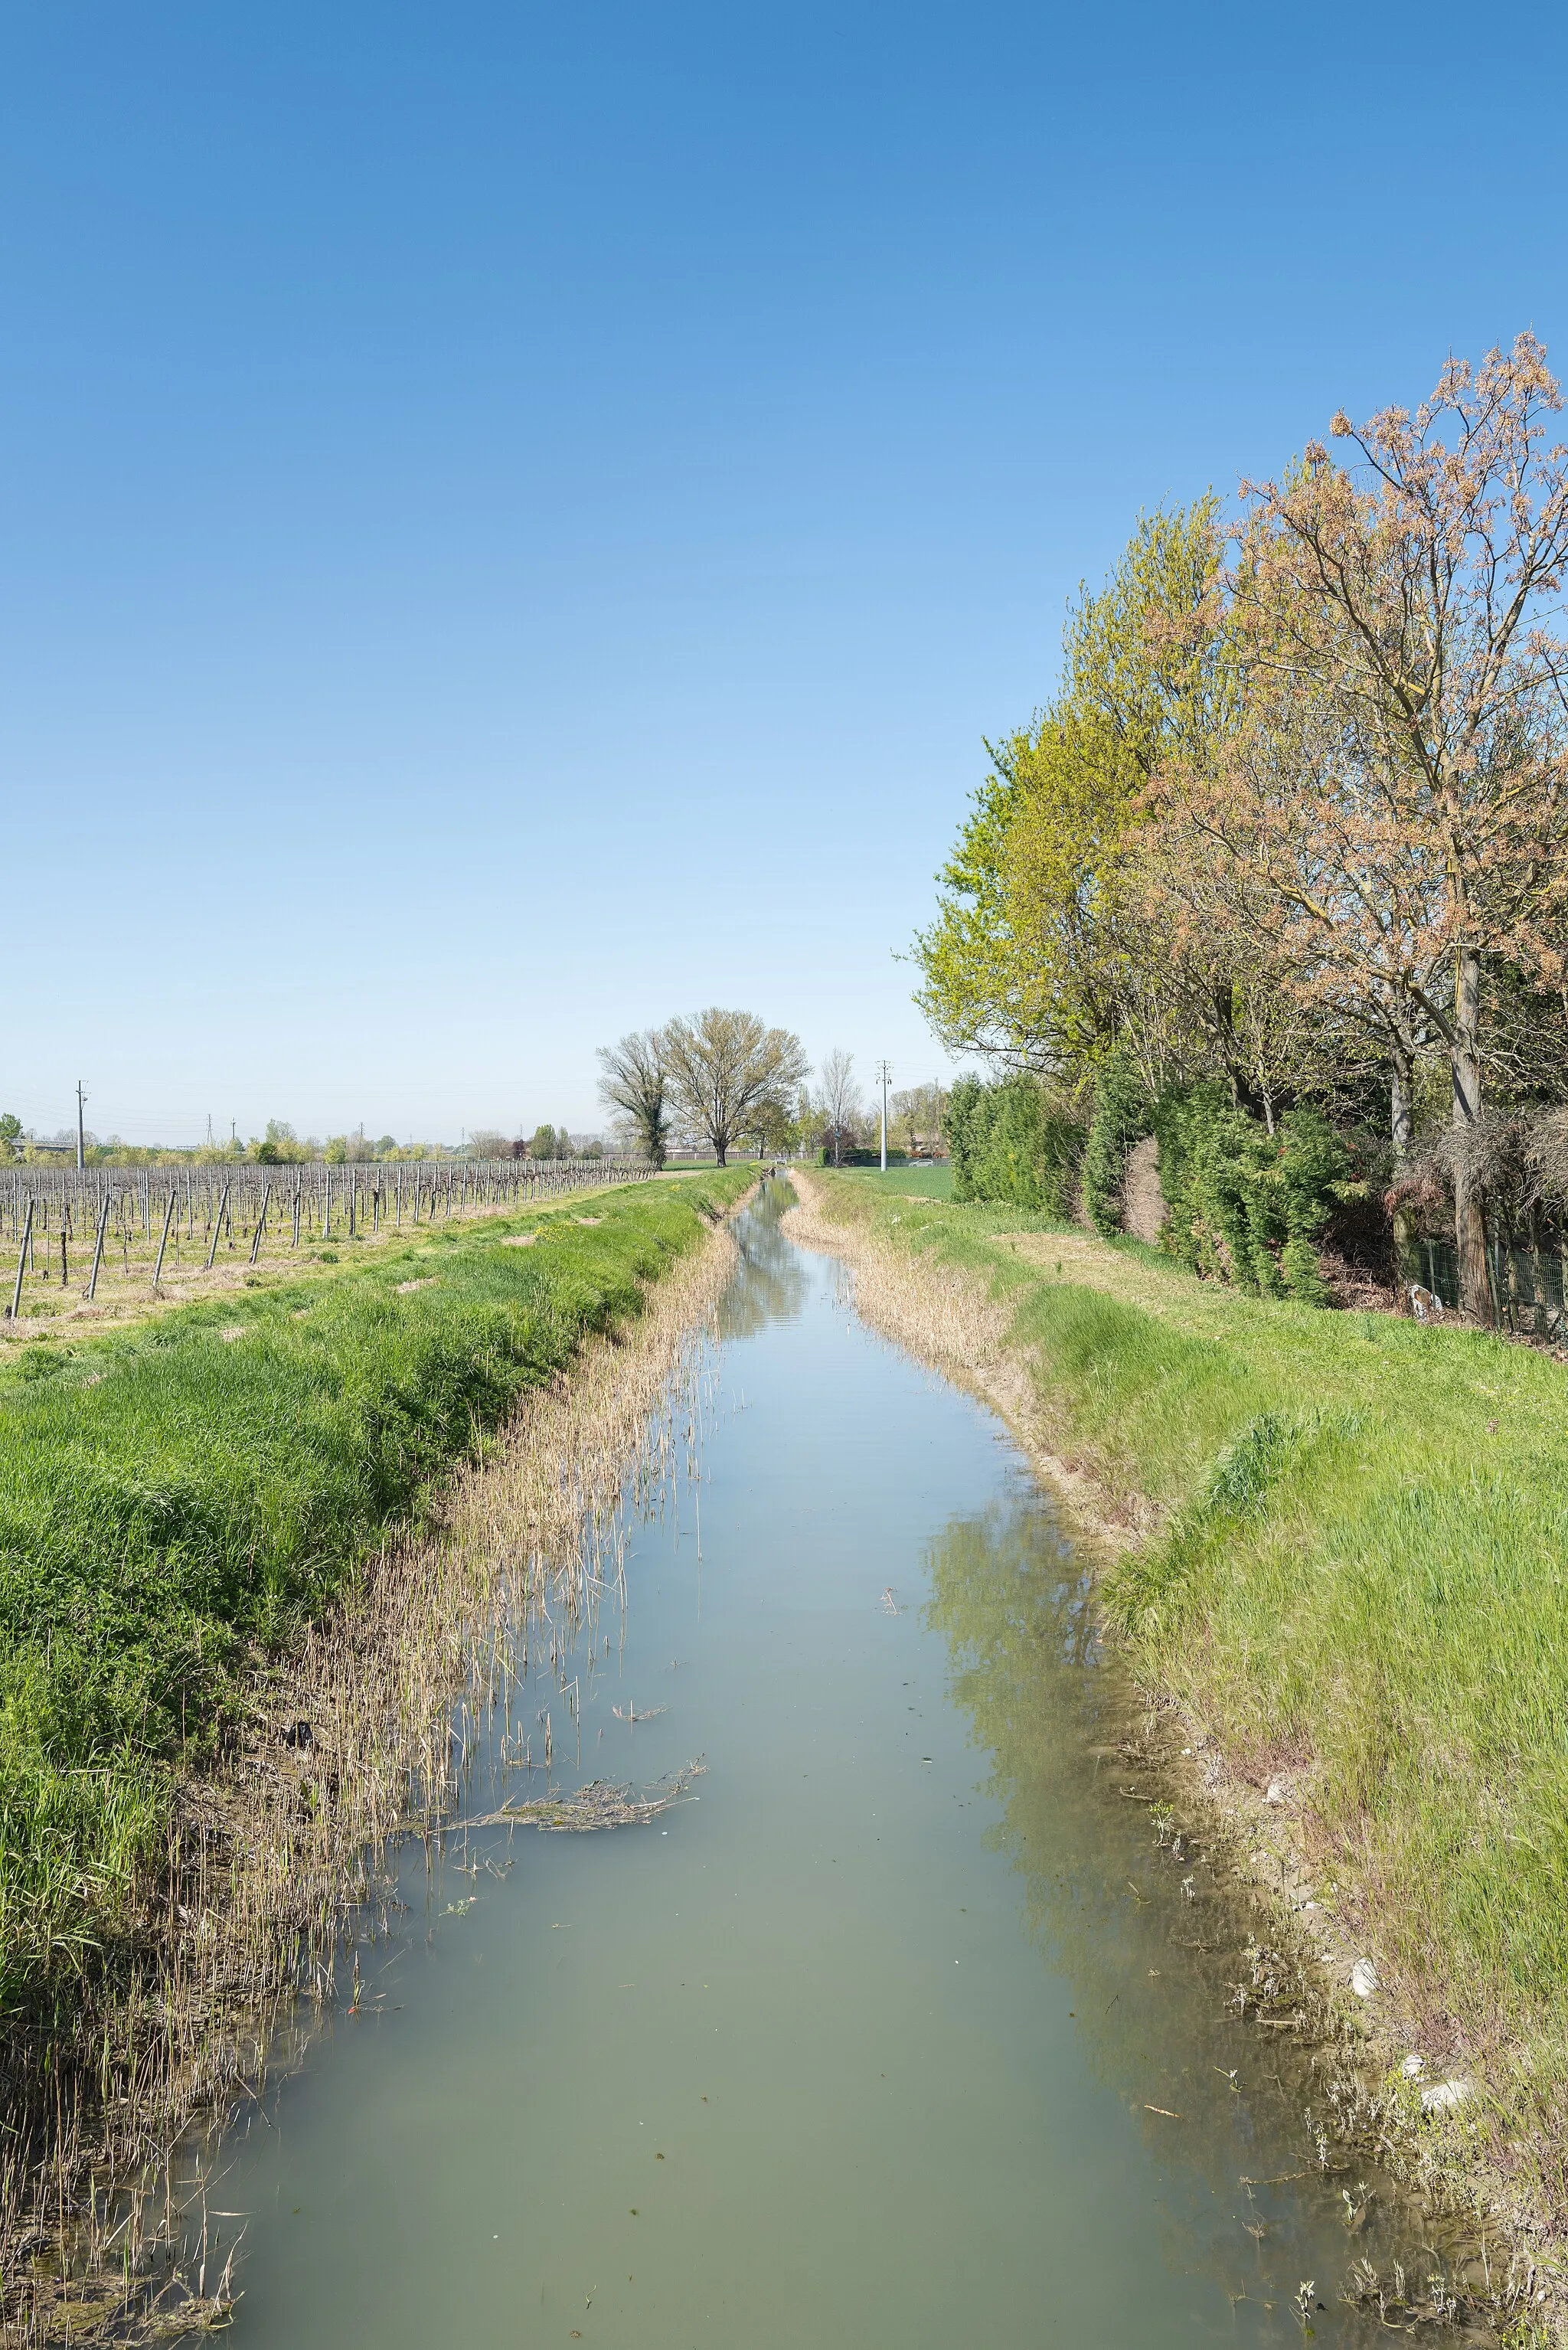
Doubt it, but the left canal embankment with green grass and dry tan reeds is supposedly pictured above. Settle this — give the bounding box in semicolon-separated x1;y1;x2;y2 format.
0;1170;755;2339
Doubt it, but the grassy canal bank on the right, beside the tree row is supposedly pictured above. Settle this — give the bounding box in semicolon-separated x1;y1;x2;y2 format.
815;1178;1568;2225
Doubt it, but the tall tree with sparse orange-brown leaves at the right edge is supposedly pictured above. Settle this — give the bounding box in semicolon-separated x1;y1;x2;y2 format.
1220;334;1568;1312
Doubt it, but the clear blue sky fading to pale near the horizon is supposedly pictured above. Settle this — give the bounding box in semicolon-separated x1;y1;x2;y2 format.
0;0;1568;1139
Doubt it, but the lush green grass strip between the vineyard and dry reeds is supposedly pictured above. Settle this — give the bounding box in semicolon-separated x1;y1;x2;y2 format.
0;1168;755;2014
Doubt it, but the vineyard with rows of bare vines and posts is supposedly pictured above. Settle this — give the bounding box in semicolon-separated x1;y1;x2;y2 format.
0;1159;648;1325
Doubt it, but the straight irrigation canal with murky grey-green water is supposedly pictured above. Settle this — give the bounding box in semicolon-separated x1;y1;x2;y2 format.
199;1191;1476;2350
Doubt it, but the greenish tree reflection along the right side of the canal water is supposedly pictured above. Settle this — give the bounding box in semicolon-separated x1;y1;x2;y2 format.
926;1473;1476;2341
